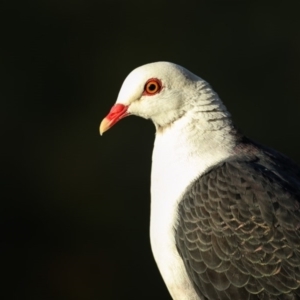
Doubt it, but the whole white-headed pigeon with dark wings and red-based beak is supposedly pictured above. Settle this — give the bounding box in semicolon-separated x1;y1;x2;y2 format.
99;61;300;300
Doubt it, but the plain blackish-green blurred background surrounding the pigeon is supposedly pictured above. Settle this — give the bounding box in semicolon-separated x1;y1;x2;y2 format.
0;0;300;300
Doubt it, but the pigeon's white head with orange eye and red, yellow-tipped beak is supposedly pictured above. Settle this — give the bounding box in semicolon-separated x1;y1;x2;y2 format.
100;62;204;135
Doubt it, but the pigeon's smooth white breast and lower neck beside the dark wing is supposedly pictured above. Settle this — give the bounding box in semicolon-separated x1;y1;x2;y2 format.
150;114;233;300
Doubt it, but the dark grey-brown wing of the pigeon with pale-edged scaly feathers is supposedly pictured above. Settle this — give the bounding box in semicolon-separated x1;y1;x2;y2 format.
175;155;300;300
